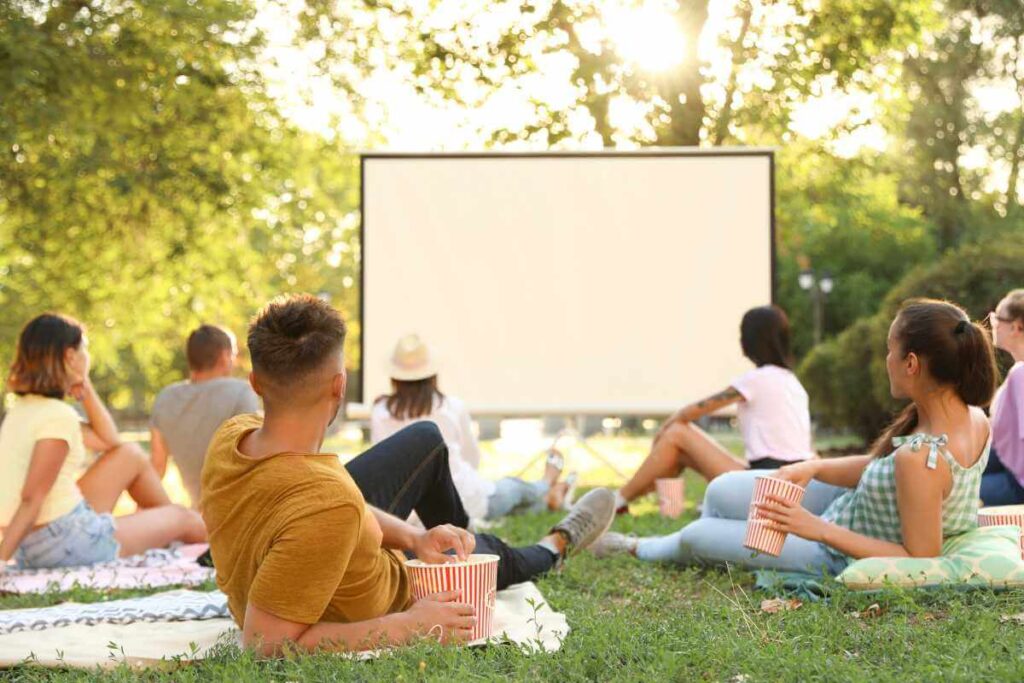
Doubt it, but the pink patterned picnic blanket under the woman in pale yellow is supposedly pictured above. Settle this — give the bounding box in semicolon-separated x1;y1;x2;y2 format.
0;544;214;593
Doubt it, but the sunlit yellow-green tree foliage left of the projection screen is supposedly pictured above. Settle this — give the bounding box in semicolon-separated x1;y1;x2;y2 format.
0;0;355;410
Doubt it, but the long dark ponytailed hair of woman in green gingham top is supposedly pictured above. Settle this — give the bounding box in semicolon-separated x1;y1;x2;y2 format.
871;299;998;458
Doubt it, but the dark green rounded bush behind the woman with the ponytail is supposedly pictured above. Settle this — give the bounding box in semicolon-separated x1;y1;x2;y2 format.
799;244;1024;439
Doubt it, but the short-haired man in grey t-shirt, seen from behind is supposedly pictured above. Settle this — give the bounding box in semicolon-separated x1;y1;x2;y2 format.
150;325;260;509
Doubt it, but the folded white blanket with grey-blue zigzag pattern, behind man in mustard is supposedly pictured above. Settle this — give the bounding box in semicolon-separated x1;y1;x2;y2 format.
0;590;230;635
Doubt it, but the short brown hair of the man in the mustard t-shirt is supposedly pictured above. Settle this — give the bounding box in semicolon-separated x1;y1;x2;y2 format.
249;294;347;386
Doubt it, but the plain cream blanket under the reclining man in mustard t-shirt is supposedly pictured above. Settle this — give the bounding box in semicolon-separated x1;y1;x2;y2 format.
0;583;569;669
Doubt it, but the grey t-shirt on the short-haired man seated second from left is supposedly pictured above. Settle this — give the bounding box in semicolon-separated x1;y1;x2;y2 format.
151;377;260;508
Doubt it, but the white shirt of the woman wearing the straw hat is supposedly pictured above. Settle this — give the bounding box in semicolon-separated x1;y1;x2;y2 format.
370;396;495;519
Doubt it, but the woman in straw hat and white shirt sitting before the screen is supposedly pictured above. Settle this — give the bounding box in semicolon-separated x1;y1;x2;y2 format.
370;335;568;519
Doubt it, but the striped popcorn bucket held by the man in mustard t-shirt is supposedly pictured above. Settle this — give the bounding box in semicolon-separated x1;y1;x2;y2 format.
406;555;499;640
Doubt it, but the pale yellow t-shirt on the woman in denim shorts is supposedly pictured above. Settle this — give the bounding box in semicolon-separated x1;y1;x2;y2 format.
0;394;85;526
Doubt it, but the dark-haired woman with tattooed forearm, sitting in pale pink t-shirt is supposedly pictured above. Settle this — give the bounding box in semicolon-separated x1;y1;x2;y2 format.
615;306;815;513
